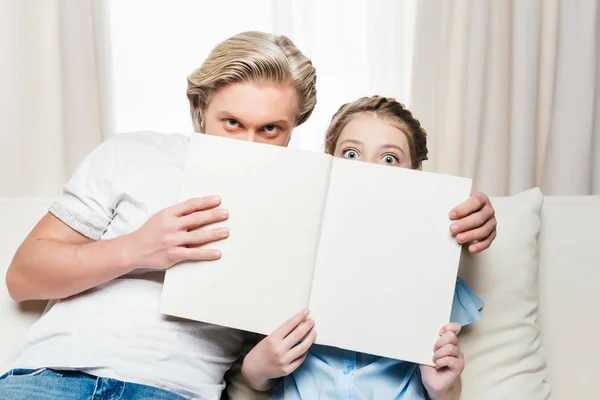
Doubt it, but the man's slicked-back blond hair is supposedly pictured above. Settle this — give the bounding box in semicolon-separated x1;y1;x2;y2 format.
187;32;317;132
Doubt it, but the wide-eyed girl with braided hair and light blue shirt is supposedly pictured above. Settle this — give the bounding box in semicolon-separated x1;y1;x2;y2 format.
242;96;483;400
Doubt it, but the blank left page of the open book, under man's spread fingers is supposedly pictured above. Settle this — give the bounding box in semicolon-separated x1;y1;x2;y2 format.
161;134;331;334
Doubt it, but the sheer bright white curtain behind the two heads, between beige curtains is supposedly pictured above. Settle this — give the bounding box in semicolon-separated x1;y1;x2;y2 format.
110;0;416;151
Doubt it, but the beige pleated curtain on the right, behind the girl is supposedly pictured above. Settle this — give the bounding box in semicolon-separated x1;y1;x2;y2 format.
411;0;600;195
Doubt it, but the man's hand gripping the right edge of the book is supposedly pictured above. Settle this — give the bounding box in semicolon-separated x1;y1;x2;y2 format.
450;193;497;253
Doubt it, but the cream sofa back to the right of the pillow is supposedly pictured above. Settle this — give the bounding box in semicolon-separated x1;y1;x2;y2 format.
539;196;600;399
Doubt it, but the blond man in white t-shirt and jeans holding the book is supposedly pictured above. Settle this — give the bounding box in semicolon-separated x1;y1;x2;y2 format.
0;32;495;400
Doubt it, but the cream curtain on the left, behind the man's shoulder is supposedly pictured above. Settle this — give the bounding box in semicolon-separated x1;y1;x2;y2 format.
0;0;114;197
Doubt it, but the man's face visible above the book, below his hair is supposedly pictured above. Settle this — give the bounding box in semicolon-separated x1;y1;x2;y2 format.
203;81;298;146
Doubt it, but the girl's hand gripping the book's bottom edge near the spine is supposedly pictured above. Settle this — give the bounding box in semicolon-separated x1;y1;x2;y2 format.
242;310;317;391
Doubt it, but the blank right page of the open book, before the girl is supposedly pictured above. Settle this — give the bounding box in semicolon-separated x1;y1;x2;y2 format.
310;159;471;365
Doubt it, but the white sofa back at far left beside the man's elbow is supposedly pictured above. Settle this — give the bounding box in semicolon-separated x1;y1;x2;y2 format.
0;198;52;366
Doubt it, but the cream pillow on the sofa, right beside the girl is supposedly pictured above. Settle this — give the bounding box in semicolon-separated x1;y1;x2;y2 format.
459;189;550;400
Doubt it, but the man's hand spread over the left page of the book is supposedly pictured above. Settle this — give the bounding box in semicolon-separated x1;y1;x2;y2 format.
124;196;229;270
